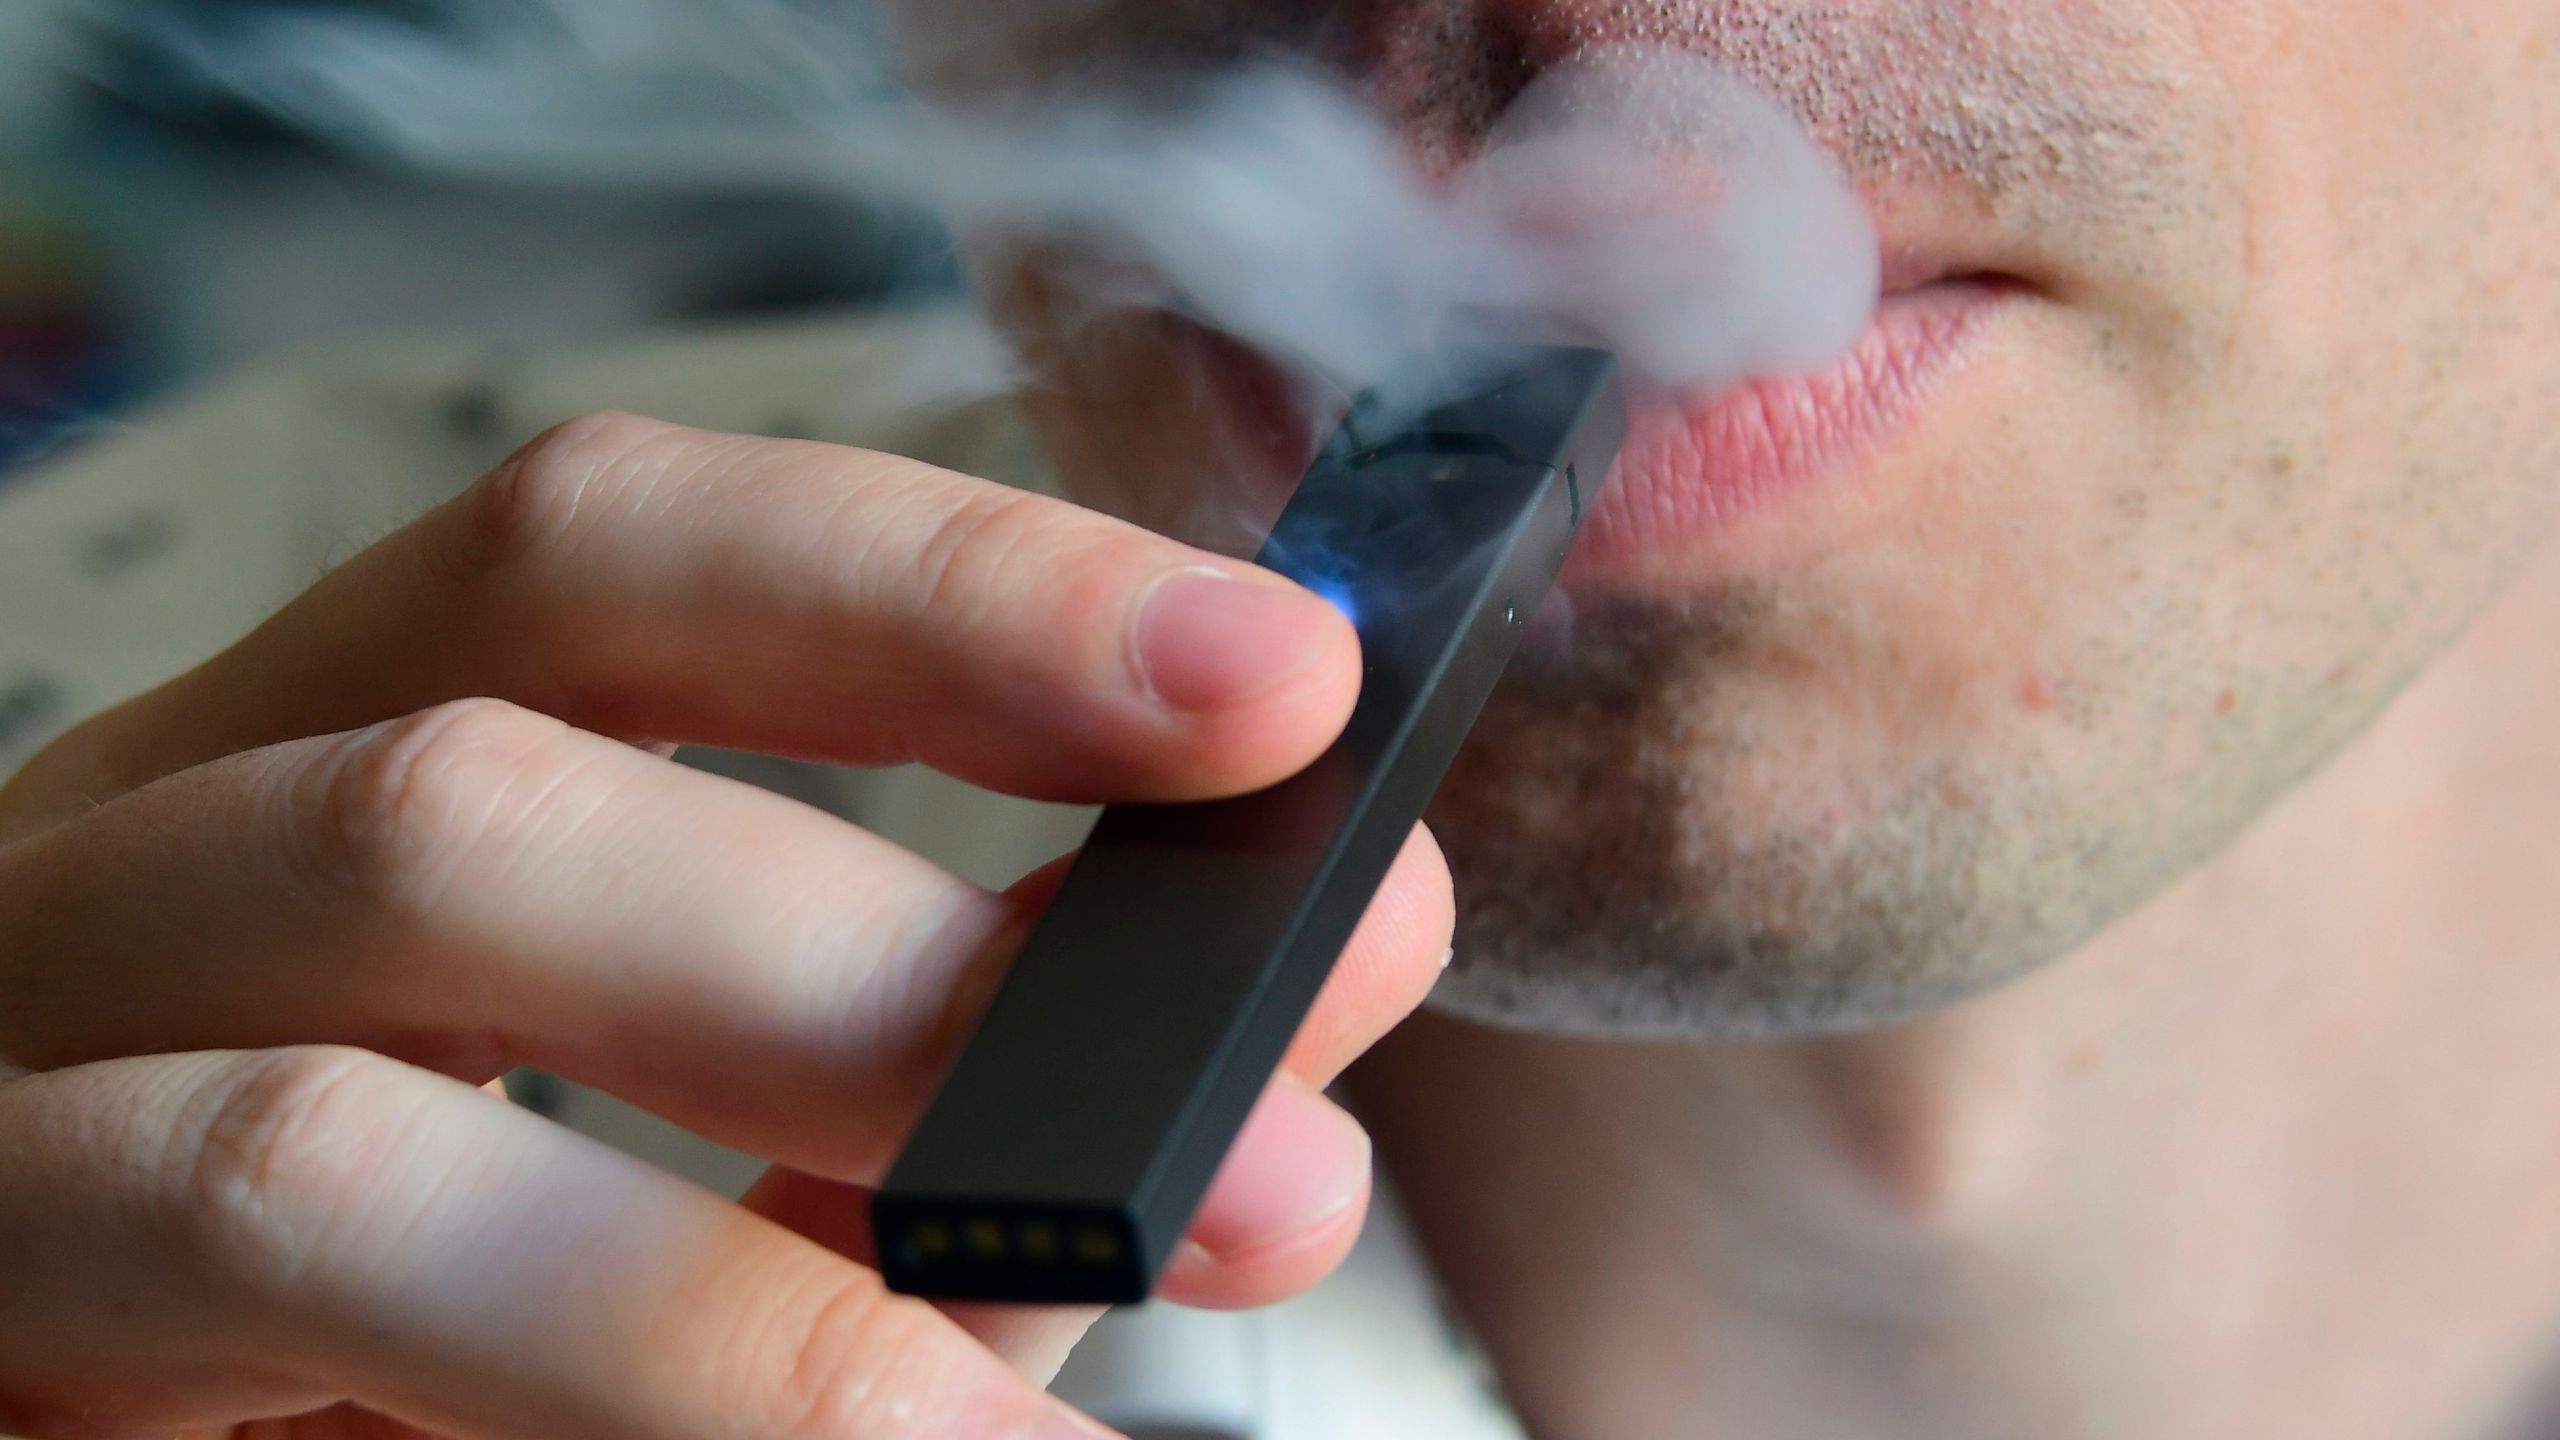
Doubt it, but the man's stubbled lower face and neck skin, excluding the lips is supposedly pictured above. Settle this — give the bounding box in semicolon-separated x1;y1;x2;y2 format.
890;0;2560;1440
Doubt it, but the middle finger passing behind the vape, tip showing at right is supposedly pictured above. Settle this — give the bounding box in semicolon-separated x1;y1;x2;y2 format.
0;702;1446;1245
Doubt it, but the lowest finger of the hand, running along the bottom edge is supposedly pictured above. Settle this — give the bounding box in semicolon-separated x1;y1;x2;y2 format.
0;1048;1121;1440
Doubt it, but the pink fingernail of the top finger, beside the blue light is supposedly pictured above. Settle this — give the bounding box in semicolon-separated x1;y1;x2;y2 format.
1132;566;1336;710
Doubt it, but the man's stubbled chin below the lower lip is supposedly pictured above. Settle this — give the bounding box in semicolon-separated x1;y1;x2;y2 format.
1428;609;2129;1038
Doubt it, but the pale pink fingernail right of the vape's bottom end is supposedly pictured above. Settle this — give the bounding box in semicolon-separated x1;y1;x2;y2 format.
1190;1076;1370;1261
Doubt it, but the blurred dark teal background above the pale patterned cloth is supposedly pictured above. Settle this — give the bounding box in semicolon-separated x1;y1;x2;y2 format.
0;0;957;487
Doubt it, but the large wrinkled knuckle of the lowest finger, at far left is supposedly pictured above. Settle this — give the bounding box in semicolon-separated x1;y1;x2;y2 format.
166;1045;407;1291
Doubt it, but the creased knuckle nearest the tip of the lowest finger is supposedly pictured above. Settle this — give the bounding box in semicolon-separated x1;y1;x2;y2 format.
765;1273;940;1440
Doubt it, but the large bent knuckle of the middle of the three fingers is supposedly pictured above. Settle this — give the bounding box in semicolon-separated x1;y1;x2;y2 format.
292;700;561;910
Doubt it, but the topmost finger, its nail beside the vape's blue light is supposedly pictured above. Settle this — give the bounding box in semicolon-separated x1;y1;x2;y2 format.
5;415;1359;812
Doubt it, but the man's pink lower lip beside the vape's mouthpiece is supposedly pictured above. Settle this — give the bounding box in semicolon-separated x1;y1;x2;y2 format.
1572;277;2017;577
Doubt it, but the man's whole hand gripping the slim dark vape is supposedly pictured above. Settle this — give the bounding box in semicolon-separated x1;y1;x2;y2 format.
0;415;1449;1440
